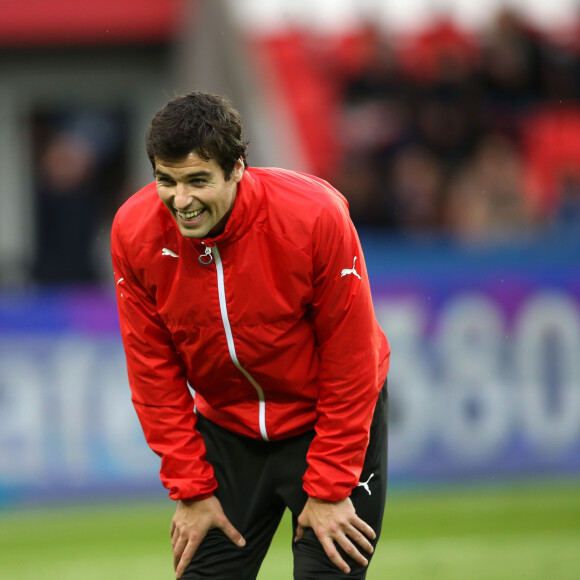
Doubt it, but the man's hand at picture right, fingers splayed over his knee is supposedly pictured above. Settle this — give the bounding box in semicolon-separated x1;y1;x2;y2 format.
294;497;376;574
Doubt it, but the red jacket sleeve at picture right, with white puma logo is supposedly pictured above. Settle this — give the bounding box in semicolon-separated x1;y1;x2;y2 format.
304;194;385;501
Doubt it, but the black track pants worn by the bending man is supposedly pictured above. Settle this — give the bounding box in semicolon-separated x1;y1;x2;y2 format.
182;385;388;580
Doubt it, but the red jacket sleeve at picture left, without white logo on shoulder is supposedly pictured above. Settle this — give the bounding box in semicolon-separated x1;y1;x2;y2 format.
111;220;217;500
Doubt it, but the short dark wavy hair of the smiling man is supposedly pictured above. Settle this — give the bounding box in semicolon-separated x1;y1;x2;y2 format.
145;91;248;180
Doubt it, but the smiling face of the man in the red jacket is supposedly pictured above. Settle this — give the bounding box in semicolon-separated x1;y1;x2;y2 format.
155;152;244;238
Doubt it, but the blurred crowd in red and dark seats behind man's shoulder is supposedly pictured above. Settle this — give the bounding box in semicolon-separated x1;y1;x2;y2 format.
325;9;580;240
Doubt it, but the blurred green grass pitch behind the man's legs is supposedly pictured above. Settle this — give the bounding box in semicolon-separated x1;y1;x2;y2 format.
0;481;580;580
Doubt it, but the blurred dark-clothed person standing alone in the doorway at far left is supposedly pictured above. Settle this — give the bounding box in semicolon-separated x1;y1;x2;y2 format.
32;107;125;284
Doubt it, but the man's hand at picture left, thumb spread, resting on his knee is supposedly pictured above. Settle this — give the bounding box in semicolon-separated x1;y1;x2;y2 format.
171;496;246;578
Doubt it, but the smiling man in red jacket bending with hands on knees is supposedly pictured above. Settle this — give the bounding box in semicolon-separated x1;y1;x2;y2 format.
112;92;389;579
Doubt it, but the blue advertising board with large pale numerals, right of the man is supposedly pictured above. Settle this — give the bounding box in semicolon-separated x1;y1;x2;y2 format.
368;233;580;481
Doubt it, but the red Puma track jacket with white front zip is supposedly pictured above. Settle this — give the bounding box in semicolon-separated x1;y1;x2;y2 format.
112;168;389;501
